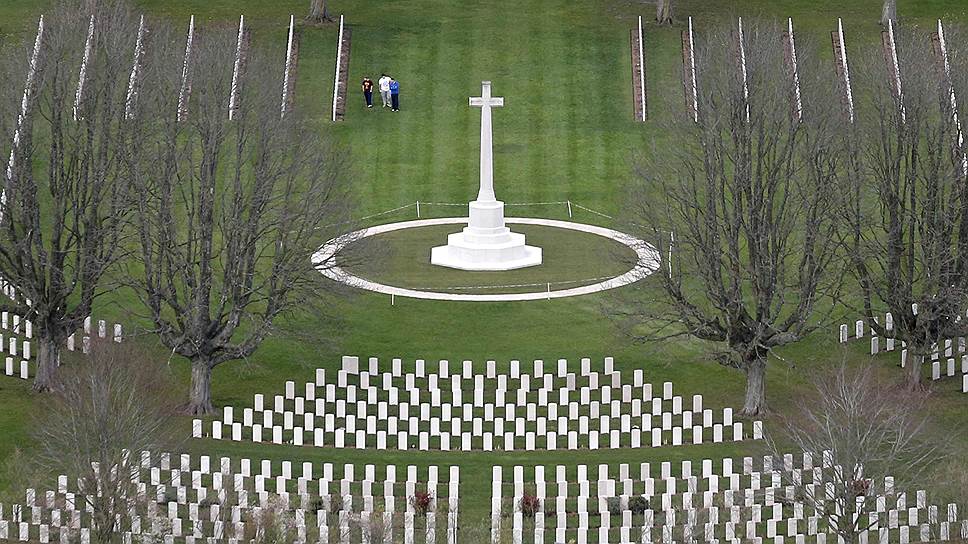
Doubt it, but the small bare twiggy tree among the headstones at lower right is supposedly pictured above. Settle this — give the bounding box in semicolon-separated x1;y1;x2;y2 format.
767;365;947;543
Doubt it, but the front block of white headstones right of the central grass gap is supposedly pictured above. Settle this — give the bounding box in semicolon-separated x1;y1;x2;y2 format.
491;455;968;544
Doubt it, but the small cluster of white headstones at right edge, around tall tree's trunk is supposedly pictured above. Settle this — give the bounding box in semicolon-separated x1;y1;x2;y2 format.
837;310;968;393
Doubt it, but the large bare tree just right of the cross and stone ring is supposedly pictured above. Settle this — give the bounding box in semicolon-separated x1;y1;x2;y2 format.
616;19;842;415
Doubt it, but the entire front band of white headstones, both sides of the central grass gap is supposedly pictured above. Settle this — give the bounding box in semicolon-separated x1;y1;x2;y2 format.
0;452;968;544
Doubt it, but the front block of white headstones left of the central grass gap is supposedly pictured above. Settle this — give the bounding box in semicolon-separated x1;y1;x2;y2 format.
0;452;460;544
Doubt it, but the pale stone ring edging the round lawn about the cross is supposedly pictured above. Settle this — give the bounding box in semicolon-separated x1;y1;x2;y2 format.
313;217;659;302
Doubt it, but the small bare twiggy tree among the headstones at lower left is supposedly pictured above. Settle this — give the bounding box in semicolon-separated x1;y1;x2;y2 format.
32;341;175;543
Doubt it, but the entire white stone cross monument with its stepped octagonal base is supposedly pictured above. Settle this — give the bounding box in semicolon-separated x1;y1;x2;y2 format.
430;81;542;270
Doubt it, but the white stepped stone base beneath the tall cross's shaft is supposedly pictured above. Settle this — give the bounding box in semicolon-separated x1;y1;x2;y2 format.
430;200;541;271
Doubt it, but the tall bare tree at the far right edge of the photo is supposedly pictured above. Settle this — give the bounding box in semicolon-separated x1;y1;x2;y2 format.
845;28;968;388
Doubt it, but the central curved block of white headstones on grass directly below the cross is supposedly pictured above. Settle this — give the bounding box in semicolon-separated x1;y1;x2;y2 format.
192;357;763;451
